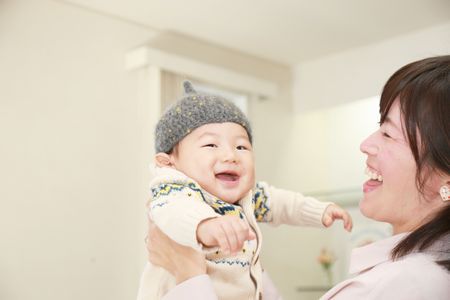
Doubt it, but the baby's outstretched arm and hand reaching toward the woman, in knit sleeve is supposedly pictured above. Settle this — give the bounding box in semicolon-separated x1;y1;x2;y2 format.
253;182;351;229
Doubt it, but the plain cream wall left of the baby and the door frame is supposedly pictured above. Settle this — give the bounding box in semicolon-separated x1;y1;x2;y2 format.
0;0;153;300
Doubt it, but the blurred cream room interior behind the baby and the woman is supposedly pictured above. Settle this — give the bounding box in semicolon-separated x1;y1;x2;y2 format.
0;0;450;300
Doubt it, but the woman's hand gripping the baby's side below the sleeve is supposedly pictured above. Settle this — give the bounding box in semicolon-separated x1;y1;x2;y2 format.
146;220;206;284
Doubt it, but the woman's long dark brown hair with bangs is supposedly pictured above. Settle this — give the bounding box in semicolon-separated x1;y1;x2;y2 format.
380;55;450;270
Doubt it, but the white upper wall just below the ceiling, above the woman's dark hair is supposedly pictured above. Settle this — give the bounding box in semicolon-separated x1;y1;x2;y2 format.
294;22;450;112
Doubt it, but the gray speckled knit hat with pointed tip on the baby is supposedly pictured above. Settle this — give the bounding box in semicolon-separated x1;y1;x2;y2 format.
155;81;252;153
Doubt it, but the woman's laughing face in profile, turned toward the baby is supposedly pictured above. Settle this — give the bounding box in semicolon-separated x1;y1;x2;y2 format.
359;99;431;234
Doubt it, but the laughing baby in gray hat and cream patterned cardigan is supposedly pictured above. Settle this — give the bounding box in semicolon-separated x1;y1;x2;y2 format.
138;82;352;300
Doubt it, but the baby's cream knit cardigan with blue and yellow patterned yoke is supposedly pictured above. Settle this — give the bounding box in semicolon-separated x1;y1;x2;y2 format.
137;168;330;300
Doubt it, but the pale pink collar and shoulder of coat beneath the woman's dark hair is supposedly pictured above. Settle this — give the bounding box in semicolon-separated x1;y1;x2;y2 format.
321;234;450;300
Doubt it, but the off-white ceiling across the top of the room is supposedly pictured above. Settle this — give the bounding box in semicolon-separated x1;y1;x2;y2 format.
61;0;450;65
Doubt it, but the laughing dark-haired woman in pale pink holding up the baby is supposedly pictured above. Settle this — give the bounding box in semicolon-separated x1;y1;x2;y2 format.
147;56;450;300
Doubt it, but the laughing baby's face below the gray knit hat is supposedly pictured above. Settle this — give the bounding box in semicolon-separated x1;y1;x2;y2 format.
171;123;255;203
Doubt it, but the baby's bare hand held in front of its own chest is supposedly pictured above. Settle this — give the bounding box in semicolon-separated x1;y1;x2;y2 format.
197;216;256;254
